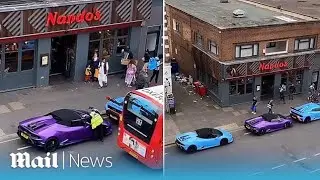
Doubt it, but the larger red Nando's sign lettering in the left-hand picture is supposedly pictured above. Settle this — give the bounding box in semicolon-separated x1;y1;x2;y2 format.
46;10;101;27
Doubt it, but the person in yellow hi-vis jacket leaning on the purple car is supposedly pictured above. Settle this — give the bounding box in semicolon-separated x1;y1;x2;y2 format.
90;110;104;141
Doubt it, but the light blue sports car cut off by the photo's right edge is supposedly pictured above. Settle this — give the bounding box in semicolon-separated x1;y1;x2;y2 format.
290;103;320;123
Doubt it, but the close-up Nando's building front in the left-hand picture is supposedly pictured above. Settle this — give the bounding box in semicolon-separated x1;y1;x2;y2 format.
0;0;163;91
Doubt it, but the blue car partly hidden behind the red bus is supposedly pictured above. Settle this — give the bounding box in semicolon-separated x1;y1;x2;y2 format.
105;96;124;121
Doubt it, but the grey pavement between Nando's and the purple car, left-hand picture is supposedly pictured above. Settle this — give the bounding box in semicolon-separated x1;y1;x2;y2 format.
0;74;162;136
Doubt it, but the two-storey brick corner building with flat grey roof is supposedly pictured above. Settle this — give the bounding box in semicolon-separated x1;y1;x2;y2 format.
166;0;320;106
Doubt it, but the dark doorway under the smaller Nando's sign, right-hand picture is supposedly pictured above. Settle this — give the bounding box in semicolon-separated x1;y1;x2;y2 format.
260;75;274;100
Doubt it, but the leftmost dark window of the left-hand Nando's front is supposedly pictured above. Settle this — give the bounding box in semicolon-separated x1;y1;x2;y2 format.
5;43;19;72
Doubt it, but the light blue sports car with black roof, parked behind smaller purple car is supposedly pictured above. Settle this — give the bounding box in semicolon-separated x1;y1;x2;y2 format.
176;128;233;153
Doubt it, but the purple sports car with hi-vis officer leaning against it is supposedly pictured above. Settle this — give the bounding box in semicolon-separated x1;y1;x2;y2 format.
17;109;112;152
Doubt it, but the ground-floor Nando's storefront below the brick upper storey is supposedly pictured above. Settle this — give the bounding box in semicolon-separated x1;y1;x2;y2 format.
191;48;320;106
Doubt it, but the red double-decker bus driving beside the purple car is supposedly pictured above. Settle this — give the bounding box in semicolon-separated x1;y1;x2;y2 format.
117;85;164;169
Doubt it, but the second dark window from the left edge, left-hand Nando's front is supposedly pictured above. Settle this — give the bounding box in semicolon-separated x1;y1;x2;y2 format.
21;41;35;71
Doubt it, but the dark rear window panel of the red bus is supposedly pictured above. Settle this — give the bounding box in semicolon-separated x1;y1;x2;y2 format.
123;94;159;144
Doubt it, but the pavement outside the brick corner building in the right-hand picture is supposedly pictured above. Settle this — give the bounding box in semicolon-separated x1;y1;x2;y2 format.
165;81;306;145
